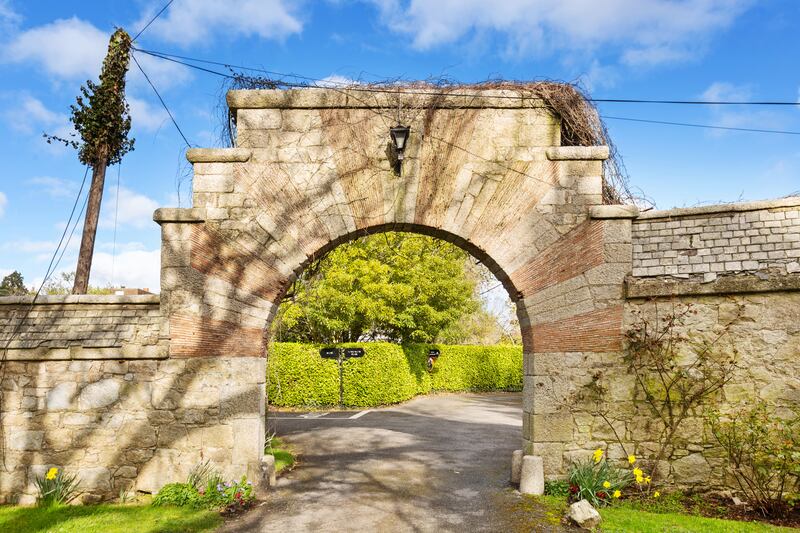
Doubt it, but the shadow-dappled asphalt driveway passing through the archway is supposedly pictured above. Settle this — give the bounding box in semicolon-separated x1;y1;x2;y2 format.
223;393;560;533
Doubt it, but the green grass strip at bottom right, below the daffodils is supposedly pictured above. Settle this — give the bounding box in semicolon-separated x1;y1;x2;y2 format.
537;496;797;533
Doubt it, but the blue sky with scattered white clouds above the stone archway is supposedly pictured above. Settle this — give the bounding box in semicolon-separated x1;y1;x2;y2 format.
0;0;800;289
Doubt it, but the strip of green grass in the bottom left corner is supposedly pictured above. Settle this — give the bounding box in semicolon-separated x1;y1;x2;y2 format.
0;505;222;533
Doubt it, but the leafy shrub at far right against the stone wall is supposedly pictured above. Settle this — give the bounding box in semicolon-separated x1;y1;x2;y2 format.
708;401;800;516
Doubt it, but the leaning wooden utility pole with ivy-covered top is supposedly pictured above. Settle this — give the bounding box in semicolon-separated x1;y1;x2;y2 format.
51;29;133;294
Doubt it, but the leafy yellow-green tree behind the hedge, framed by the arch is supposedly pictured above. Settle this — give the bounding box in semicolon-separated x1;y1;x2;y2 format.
275;232;480;343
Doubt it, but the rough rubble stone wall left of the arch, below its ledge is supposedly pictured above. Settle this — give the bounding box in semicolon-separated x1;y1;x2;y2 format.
0;357;266;502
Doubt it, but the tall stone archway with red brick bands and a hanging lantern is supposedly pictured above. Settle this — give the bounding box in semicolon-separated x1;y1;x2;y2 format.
151;89;635;486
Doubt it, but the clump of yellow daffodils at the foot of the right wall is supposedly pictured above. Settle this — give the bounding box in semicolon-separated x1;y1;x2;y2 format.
569;450;632;507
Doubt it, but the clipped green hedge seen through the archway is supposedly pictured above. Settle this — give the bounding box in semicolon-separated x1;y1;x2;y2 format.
267;342;522;407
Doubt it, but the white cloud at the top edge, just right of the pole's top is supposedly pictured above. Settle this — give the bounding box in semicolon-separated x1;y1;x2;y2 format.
135;0;303;46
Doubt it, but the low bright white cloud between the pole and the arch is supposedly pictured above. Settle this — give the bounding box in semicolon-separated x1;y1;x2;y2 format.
91;245;161;292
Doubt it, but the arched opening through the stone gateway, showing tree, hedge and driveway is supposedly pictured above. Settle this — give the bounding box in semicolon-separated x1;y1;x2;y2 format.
266;225;524;530
